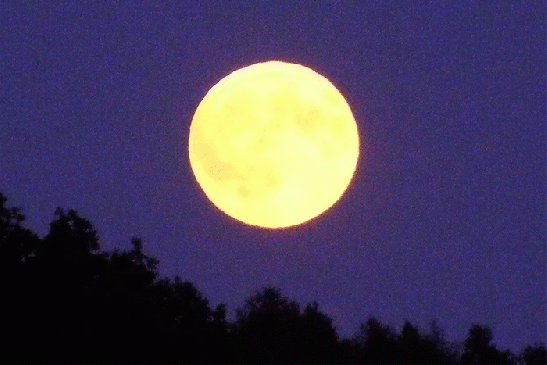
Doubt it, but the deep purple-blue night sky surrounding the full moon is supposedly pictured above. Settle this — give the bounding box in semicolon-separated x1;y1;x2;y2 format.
0;0;547;352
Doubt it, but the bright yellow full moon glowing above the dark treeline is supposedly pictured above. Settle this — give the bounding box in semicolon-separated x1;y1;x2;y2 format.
188;61;359;228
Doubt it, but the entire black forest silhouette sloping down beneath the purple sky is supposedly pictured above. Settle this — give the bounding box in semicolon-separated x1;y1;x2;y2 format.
0;193;547;364
